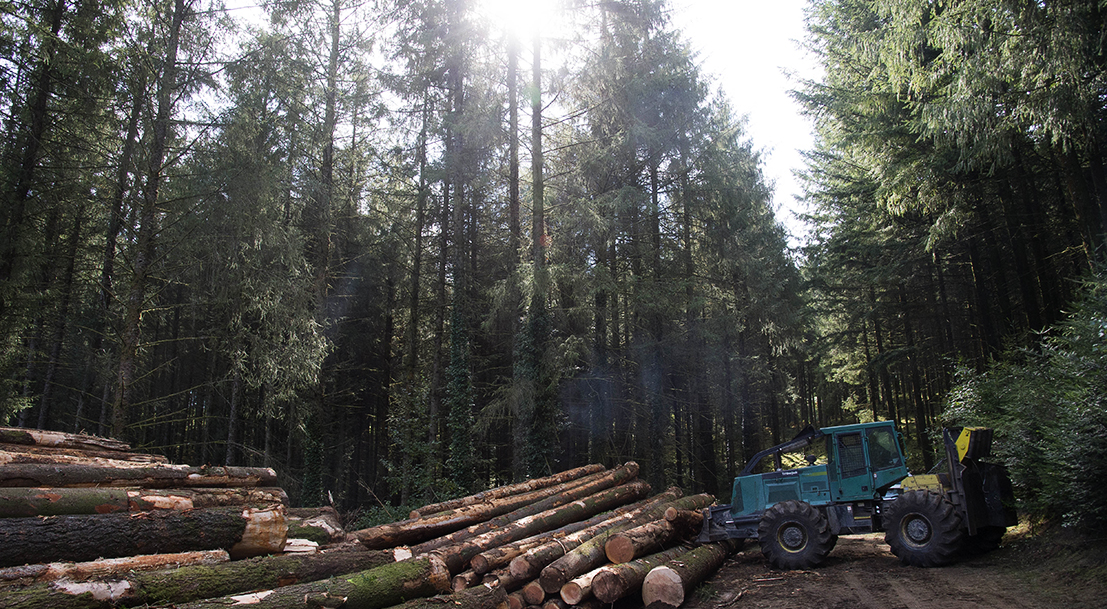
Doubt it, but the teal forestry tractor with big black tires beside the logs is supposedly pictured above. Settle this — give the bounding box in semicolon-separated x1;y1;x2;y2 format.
697;421;1017;569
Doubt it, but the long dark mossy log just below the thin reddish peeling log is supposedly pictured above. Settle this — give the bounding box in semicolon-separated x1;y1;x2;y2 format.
0;546;393;609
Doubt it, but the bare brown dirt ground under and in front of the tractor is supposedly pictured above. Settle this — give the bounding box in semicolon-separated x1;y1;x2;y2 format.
682;527;1107;609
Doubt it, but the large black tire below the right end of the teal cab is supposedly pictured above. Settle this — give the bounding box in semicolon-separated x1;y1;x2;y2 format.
884;491;964;567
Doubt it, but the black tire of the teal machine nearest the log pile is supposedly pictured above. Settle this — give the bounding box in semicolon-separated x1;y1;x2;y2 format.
757;500;837;570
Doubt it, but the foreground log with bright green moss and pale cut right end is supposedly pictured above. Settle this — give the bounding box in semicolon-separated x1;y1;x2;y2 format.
159;556;449;609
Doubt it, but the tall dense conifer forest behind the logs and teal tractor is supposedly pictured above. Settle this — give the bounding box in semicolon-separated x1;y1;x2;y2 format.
0;0;1107;529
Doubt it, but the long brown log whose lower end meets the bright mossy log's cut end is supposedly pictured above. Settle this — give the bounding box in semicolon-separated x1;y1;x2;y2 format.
434;481;650;574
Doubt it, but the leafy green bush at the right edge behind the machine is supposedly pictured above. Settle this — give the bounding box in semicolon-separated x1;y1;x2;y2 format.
945;270;1107;529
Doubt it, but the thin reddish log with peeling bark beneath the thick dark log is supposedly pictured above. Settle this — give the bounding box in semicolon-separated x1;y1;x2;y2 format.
0;550;230;585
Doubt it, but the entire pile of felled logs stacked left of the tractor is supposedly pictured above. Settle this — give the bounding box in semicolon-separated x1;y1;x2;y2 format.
0;427;734;609
